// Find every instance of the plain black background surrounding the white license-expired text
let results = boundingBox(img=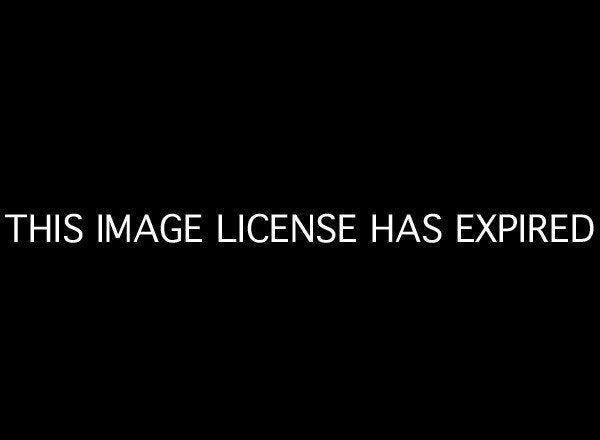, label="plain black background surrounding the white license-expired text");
[1,5,598,433]
